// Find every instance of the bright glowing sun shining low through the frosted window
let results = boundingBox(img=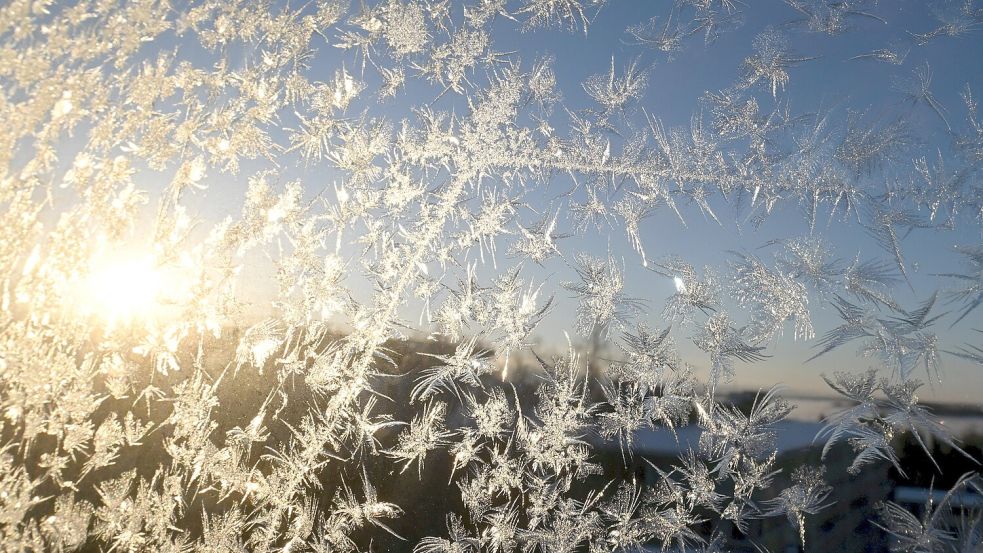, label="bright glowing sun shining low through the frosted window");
[79,255,165,329]
